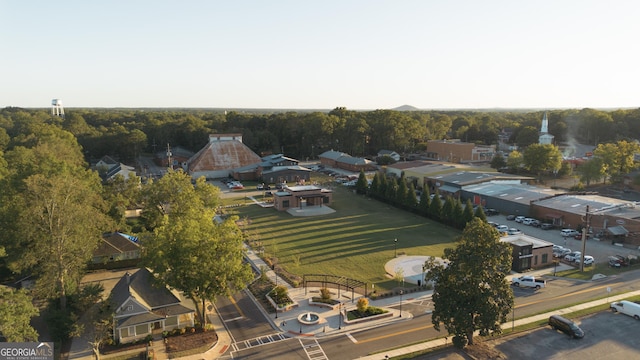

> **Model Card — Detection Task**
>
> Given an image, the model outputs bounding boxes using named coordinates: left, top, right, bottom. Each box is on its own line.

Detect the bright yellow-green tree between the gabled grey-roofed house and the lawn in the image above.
left=143, top=171, right=251, bottom=320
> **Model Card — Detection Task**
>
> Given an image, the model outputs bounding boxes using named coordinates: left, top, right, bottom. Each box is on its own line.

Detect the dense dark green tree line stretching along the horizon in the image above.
left=0, top=107, right=640, bottom=163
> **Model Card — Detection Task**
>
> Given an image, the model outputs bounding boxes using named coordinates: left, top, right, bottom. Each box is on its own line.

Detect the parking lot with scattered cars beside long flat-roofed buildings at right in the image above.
left=487, top=215, right=640, bottom=271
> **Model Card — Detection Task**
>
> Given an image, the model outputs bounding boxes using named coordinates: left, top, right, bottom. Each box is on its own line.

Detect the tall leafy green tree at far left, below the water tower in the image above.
left=0, top=124, right=110, bottom=309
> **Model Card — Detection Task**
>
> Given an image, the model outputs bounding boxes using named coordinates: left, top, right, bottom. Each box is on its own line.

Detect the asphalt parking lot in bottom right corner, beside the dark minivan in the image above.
left=491, top=311, right=640, bottom=360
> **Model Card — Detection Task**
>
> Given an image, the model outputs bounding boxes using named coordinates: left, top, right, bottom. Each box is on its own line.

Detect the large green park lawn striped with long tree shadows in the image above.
left=227, top=186, right=460, bottom=290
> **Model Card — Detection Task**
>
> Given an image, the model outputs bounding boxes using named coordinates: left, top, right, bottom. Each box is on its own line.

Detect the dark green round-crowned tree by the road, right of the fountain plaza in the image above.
left=426, top=218, right=513, bottom=347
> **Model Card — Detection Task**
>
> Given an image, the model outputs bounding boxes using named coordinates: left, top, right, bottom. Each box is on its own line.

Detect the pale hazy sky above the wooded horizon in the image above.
left=0, top=0, right=640, bottom=110
